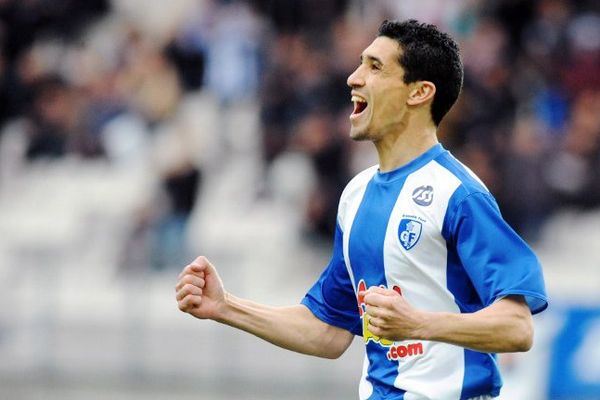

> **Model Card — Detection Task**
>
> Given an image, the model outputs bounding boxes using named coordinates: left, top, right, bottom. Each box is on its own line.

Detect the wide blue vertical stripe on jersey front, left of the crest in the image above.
left=348, top=176, right=406, bottom=400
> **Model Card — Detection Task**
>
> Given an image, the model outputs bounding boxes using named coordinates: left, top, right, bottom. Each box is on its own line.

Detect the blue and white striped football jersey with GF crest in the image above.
left=302, top=144, right=547, bottom=400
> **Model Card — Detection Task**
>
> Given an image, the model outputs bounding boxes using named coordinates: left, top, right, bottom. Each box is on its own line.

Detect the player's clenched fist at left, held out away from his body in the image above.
left=175, top=256, right=225, bottom=320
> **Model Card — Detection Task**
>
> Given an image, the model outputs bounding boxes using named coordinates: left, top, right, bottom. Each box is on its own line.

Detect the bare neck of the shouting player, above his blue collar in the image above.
left=374, top=124, right=438, bottom=172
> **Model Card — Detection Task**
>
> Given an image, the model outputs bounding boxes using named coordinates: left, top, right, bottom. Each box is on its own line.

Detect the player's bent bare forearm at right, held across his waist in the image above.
left=422, top=298, right=533, bottom=353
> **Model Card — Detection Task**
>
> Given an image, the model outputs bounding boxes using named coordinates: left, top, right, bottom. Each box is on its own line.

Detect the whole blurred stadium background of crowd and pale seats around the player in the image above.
left=0, top=0, right=600, bottom=400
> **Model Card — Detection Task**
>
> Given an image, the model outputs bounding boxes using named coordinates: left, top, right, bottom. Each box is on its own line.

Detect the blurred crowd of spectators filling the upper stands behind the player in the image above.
left=0, top=0, right=600, bottom=268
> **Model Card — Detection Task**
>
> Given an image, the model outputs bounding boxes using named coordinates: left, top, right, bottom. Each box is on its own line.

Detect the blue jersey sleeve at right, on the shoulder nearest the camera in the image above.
left=449, top=192, right=548, bottom=314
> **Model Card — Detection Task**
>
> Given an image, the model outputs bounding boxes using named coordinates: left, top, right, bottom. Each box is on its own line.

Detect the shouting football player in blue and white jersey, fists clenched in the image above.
left=176, top=20, right=547, bottom=400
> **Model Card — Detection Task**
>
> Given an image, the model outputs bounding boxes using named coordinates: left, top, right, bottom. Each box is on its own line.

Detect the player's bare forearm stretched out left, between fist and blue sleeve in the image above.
left=216, top=294, right=353, bottom=358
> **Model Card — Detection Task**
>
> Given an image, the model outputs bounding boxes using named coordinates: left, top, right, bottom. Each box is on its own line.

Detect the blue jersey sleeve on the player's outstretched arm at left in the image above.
left=302, top=225, right=362, bottom=335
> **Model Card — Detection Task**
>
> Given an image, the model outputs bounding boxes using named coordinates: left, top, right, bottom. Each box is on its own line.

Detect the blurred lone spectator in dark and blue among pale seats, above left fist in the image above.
left=121, top=124, right=203, bottom=272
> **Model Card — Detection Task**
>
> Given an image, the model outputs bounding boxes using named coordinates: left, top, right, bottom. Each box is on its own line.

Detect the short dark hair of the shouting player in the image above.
left=377, top=19, right=463, bottom=126
